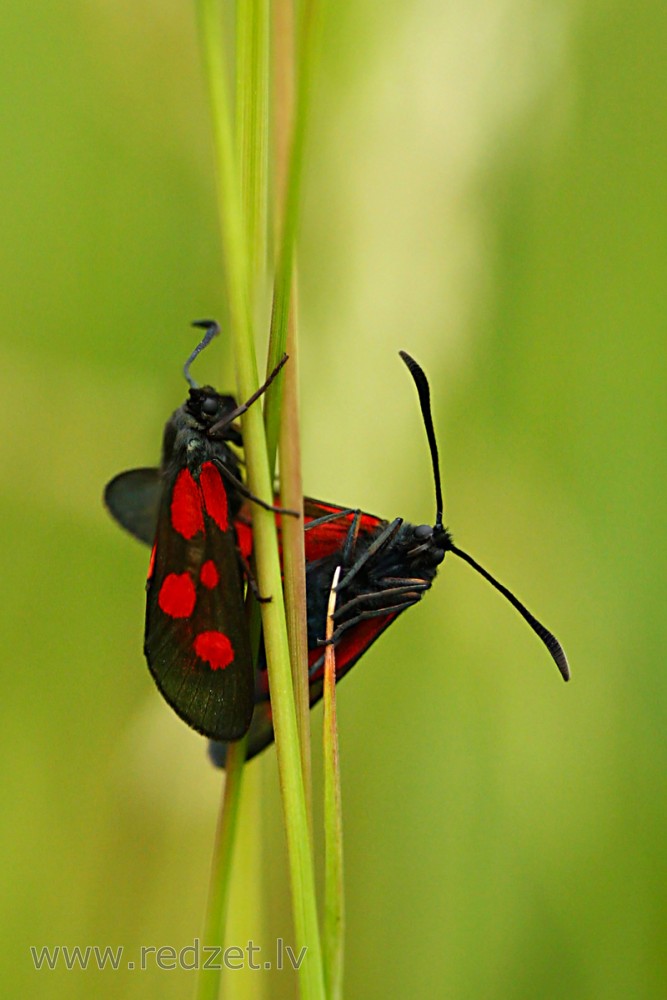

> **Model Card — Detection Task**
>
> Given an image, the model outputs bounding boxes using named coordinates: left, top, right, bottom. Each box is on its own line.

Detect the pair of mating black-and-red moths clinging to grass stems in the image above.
left=104, top=320, right=570, bottom=763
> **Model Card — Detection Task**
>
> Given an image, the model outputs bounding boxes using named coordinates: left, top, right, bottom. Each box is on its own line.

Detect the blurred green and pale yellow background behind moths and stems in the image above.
left=0, top=0, right=667, bottom=1000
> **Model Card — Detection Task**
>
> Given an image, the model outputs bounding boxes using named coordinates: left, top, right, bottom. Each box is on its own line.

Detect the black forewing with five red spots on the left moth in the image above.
left=145, top=462, right=254, bottom=740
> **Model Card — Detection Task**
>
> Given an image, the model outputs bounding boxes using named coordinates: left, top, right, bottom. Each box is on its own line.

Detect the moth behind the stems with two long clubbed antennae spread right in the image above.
left=210, top=351, right=570, bottom=766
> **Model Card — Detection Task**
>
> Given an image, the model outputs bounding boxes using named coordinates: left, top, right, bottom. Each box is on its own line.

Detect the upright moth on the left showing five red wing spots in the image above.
left=104, top=320, right=286, bottom=740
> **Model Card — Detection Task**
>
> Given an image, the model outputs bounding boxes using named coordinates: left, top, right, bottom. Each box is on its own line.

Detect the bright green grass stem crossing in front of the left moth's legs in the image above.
left=198, top=0, right=324, bottom=1000
